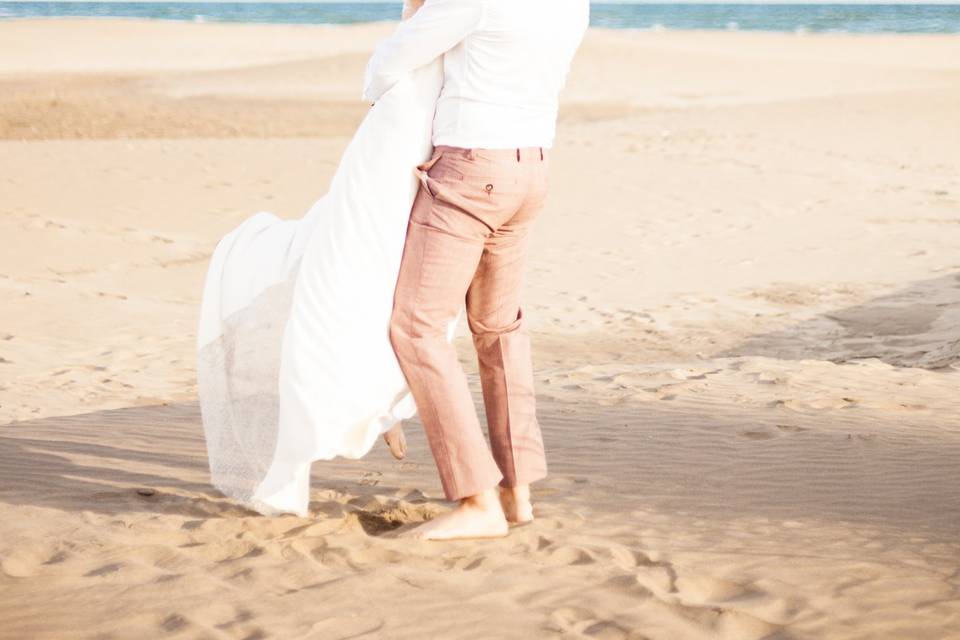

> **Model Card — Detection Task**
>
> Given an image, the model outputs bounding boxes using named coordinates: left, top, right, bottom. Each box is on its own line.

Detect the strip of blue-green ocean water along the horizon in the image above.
left=0, top=0, right=960, bottom=33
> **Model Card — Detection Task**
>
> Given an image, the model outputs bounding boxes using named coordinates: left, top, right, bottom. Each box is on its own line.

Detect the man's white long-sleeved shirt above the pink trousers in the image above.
left=363, top=0, right=590, bottom=149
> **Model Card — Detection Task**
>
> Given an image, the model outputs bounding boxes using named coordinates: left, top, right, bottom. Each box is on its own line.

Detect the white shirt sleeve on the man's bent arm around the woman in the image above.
left=363, top=0, right=483, bottom=102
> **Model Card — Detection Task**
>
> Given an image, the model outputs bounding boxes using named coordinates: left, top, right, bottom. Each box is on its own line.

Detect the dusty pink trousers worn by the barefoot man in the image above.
left=390, top=146, right=549, bottom=500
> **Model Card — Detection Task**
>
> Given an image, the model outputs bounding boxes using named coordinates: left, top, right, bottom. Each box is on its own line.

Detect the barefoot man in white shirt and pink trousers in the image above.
left=364, top=0, right=589, bottom=540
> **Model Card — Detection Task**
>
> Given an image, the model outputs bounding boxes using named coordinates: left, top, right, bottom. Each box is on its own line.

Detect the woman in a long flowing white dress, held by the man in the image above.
left=197, top=0, right=448, bottom=516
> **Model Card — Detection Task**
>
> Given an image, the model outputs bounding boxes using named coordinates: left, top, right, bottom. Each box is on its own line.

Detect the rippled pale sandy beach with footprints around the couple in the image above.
left=0, top=19, right=960, bottom=640
